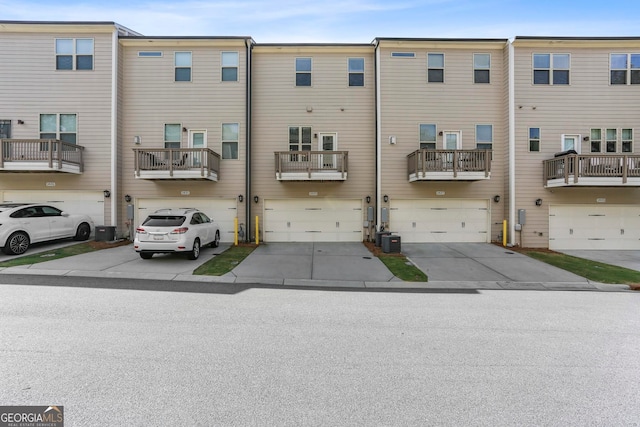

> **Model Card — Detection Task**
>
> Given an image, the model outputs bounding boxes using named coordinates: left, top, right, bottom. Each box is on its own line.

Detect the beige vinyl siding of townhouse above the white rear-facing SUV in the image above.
left=121, top=40, right=247, bottom=232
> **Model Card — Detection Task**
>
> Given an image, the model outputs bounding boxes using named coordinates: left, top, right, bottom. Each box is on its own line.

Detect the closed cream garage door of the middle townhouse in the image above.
left=264, top=199, right=363, bottom=242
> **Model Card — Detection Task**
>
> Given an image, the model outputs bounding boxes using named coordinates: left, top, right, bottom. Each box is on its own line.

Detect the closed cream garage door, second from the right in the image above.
left=389, top=199, right=490, bottom=243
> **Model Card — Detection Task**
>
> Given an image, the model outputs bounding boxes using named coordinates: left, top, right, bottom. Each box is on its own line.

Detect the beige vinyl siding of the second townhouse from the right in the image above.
left=380, top=42, right=508, bottom=244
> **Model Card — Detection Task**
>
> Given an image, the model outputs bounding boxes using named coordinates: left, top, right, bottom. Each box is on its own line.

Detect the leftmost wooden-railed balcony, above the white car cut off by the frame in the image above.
left=0, top=139, right=84, bottom=174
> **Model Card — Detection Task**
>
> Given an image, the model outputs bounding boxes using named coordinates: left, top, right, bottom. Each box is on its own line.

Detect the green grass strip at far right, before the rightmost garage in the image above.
left=522, top=250, right=640, bottom=284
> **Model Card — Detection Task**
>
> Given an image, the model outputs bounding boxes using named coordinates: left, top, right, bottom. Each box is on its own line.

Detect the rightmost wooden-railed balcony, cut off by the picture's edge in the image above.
left=543, top=154, right=640, bottom=188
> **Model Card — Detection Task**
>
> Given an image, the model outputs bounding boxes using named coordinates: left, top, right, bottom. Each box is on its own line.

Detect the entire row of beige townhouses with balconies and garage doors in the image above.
left=0, top=21, right=640, bottom=249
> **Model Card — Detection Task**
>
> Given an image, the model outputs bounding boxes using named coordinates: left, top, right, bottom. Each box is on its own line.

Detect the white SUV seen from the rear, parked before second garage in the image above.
left=133, top=208, right=220, bottom=259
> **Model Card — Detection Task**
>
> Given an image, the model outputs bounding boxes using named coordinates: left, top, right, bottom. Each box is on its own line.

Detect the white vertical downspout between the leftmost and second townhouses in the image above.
left=110, top=27, right=120, bottom=226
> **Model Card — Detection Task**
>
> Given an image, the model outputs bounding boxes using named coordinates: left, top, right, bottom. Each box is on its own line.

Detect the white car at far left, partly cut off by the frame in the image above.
left=0, top=203, right=94, bottom=255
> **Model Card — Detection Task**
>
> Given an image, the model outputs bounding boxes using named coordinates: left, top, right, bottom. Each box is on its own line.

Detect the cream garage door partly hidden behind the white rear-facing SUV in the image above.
left=139, top=197, right=238, bottom=242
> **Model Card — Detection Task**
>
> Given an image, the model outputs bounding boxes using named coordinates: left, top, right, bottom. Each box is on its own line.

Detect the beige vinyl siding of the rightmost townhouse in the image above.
left=514, top=41, right=640, bottom=247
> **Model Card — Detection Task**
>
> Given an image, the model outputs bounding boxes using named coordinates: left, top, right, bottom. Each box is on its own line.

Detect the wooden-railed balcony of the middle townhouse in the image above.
left=275, top=151, right=349, bottom=181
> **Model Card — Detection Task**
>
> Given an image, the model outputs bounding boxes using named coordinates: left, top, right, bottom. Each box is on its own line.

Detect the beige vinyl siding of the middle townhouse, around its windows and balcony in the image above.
left=252, top=45, right=376, bottom=242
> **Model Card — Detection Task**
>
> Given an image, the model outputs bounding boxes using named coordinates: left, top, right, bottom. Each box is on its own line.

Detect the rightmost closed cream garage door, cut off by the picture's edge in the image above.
left=549, top=205, right=640, bottom=250
